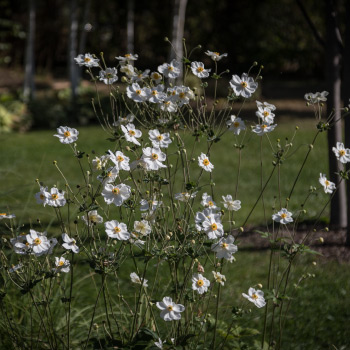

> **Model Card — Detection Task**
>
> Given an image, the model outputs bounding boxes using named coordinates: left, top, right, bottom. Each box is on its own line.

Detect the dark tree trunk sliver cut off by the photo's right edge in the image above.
left=342, top=0, right=350, bottom=242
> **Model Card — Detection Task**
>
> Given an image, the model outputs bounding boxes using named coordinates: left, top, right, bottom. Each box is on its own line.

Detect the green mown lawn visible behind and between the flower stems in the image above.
left=0, top=120, right=350, bottom=350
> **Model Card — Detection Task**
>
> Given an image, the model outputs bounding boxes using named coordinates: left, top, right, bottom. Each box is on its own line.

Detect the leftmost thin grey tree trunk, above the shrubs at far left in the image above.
left=23, top=0, right=36, bottom=102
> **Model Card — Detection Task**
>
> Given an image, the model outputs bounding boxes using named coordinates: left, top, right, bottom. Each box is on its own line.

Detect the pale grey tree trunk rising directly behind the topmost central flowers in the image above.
left=169, top=0, right=187, bottom=79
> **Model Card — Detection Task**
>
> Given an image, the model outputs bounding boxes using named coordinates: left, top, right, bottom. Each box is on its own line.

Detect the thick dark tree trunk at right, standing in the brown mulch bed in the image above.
left=326, top=0, right=347, bottom=228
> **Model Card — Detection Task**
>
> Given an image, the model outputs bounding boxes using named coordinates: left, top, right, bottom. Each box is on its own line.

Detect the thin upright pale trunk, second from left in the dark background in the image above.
left=68, top=0, right=78, bottom=104
